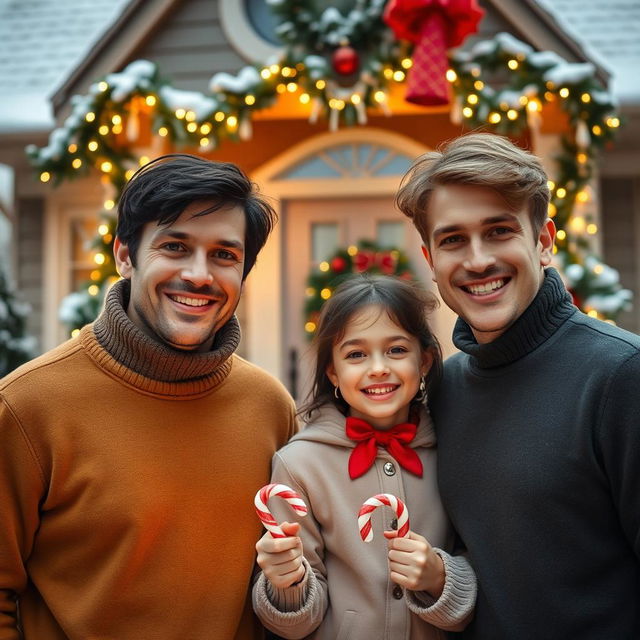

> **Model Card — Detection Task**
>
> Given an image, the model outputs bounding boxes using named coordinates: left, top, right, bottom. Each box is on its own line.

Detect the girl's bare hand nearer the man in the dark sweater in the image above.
left=384, top=531, right=445, bottom=600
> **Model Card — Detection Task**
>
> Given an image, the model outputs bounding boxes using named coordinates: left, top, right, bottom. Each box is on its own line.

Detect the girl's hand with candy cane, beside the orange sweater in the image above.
left=255, top=484, right=307, bottom=589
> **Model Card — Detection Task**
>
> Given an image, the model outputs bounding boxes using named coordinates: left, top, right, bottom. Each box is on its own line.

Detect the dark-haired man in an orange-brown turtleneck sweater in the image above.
left=0, top=154, right=296, bottom=640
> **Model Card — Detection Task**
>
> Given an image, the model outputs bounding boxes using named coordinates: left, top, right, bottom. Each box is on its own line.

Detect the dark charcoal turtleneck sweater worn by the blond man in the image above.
left=431, top=268, right=640, bottom=640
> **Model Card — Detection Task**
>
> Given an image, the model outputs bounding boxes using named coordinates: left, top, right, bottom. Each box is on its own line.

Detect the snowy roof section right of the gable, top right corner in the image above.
left=536, top=0, right=640, bottom=103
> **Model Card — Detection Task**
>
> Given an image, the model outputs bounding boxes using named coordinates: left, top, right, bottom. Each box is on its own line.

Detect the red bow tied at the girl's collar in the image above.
left=346, top=416, right=422, bottom=480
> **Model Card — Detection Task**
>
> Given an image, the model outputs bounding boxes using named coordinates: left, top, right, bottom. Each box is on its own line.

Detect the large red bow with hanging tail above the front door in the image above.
left=383, top=0, right=484, bottom=105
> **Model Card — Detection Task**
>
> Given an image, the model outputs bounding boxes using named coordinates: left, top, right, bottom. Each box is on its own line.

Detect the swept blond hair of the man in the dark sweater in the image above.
left=396, top=133, right=550, bottom=245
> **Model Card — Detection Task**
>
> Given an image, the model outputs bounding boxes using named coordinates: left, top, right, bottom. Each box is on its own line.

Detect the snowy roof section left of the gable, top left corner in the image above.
left=0, top=0, right=130, bottom=132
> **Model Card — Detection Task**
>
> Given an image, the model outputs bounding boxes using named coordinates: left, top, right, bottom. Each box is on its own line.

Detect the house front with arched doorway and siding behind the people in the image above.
left=0, top=0, right=640, bottom=397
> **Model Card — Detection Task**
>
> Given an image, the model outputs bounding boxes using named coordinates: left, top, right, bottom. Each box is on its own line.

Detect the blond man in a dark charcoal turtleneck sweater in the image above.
left=397, top=133, right=640, bottom=640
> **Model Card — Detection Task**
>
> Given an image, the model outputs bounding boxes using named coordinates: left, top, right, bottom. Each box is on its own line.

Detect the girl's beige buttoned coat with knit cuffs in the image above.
left=253, top=406, right=476, bottom=640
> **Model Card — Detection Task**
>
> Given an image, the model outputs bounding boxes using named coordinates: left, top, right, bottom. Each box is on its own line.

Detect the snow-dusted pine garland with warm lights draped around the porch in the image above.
left=27, top=11, right=631, bottom=328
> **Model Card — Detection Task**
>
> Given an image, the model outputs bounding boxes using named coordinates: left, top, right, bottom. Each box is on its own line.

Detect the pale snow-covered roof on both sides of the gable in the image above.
left=0, top=0, right=640, bottom=133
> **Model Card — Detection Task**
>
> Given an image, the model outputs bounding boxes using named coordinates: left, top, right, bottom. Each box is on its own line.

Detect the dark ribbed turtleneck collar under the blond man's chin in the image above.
left=453, top=268, right=576, bottom=369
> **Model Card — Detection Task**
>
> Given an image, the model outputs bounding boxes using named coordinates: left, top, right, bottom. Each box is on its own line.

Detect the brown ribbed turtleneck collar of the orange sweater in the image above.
left=80, top=280, right=240, bottom=395
